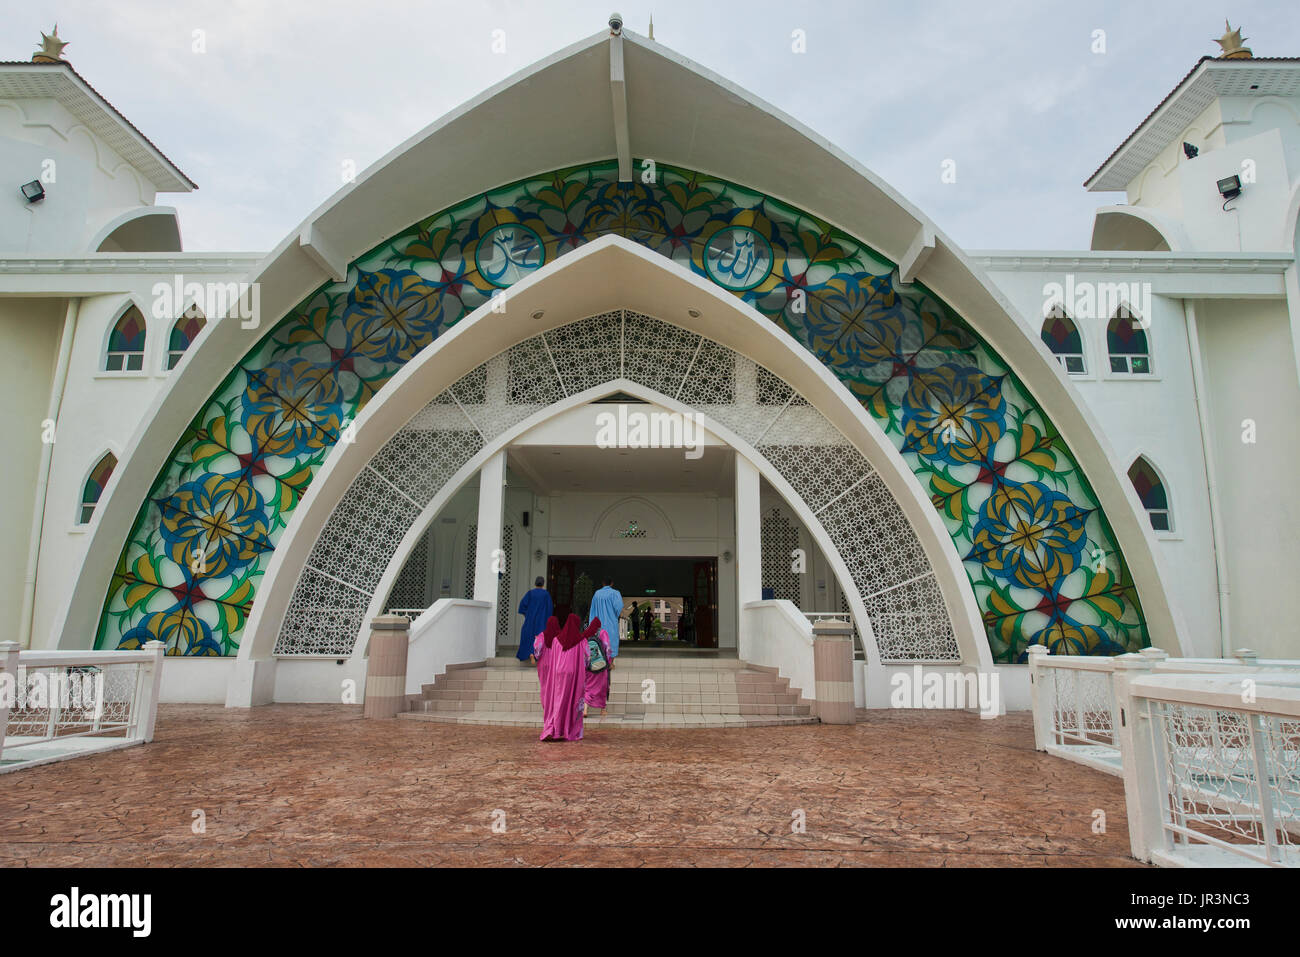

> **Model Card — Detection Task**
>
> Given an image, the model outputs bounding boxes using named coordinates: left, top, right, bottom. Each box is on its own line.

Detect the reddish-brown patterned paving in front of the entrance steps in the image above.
left=0, top=705, right=1135, bottom=866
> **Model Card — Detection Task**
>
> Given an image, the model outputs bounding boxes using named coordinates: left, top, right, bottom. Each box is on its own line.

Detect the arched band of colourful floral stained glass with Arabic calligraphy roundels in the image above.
left=98, top=160, right=1148, bottom=662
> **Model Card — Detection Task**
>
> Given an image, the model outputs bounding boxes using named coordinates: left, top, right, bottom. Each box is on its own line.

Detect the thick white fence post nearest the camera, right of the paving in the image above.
left=1110, top=651, right=1169, bottom=861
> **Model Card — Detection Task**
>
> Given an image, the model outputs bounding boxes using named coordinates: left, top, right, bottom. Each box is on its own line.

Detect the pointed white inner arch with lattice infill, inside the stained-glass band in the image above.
left=223, top=237, right=989, bottom=702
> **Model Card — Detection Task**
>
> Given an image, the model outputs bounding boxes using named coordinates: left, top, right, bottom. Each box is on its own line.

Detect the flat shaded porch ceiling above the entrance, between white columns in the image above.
left=507, top=446, right=736, bottom=495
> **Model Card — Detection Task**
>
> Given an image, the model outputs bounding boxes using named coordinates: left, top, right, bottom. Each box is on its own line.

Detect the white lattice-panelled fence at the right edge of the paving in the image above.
left=1030, top=649, right=1300, bottom=867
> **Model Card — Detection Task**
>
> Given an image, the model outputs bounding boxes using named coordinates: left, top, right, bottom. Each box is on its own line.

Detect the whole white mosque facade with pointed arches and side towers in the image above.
left=0, top=24, right=1300, bottom=707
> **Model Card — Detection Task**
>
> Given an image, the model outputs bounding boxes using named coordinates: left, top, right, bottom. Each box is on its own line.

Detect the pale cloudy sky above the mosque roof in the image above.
left=10, top=0, right=1300, bottom=251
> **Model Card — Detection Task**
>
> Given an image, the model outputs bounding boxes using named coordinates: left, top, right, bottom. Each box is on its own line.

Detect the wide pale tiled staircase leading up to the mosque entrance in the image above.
left=398, top=645, right=818, bottom=728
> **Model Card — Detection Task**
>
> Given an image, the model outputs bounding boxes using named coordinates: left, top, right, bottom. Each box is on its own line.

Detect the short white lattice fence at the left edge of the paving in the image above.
left=0, top=641, right=164, bottom=772
